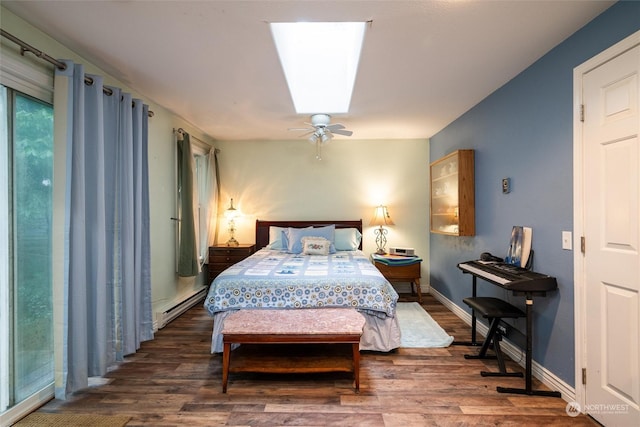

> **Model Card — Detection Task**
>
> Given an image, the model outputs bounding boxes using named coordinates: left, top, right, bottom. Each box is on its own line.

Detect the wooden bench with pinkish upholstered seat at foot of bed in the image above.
left=222, top=308, right=365, bottom=393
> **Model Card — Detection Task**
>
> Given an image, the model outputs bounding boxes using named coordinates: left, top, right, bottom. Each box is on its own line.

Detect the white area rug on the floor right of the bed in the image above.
left=396, top=302, right=453, bottom=348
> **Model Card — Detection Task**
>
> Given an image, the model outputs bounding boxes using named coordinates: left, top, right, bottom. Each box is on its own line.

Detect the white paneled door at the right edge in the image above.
left=582, top=38, right=640, bottom=427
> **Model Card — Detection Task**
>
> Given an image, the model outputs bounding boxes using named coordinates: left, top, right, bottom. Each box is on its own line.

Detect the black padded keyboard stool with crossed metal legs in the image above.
left=462, top=297, right=526, bottom=377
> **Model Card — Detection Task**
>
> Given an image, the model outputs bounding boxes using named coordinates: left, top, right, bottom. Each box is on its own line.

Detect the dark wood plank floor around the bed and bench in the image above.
left=31, top=295, right=598, bottom=427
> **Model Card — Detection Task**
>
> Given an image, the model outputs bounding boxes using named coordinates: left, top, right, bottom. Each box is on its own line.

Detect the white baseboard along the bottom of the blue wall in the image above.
left=429, top=288, right=576, bottom=402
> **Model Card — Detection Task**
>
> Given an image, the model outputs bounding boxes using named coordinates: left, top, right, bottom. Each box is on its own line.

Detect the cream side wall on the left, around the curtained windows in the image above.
left=0, top=8, right=215, bottom=318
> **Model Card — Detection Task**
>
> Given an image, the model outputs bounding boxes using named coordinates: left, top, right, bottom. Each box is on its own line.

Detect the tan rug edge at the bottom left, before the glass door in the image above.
left=14, top=412, right=131, bottom=427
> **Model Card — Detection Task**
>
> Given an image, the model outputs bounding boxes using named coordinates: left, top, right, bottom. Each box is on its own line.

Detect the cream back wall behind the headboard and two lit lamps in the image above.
left=216, top=137, right=429, bottom=284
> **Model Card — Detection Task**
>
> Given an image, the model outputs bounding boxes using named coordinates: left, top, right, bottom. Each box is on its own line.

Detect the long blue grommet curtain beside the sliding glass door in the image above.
left=54, top=61, right=153, bottom=399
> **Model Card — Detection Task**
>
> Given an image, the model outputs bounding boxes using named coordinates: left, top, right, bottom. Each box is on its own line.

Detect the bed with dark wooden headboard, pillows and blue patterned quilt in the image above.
left=204, top=220, right=400, bottom=353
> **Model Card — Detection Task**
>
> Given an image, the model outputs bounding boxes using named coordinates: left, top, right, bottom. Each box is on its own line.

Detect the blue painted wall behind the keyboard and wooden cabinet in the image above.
left=429, top=1, right=640, bottom=386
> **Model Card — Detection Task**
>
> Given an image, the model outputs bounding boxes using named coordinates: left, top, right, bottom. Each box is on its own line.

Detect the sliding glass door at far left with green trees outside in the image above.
left=0, top=86, right=54, bottom=413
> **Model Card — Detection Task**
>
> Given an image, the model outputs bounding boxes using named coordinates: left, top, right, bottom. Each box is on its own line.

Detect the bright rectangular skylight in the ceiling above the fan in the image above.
left=270, top=22, right=366, bottom=114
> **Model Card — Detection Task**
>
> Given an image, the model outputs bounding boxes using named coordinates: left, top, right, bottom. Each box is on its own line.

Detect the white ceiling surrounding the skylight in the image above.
left=2, top=0, right=614, bottom=140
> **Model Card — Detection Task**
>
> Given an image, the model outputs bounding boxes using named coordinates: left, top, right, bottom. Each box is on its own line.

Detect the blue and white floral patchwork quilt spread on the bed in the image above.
left=204, top=249, right=398, bottom=317
